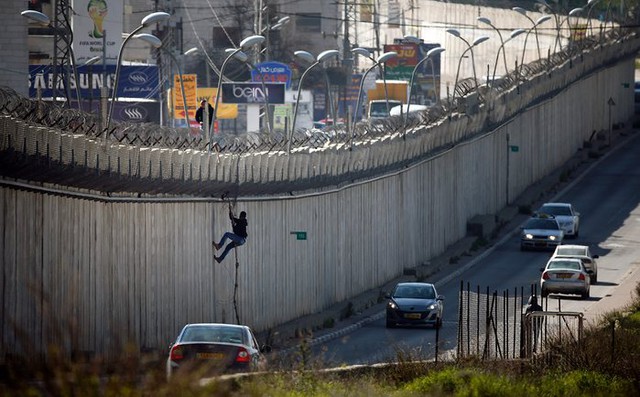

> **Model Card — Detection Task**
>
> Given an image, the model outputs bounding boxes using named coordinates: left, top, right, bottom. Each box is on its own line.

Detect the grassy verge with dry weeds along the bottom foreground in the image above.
left=0, top=285, right=640, bottom=397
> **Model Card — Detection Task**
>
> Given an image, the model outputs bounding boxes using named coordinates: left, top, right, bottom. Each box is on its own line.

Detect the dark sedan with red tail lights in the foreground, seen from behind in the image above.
left=167, top=323, right=271, bottom=379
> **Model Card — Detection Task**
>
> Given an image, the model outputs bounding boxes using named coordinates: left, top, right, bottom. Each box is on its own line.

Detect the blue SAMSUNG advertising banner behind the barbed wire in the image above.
left=29, top=65, right=160, bottom=99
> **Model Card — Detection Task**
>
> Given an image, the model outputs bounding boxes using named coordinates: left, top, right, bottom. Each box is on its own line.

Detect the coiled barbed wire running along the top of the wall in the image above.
left=0, top=24, right=625, bottom=154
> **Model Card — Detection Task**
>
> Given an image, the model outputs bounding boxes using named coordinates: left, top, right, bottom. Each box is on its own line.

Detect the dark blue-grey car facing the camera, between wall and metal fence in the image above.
left=387, top=282, right=444, bottom=328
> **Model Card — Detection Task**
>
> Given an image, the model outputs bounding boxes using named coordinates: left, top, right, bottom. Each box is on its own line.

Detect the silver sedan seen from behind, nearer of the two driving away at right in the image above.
left=540, top=257, right=591, bottom=299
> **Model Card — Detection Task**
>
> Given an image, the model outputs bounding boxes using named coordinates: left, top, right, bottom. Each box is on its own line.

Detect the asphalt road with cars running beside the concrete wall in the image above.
left=296, top=135, right=640, bottom=367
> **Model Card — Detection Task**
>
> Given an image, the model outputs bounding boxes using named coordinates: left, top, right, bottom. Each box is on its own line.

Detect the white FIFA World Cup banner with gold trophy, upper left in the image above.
left=71, top=0, right=124, bottom=65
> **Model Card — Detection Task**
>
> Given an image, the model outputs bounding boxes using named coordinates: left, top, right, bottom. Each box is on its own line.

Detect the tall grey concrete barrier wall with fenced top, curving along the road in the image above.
left=0, top=30, right=639, bottom=358
